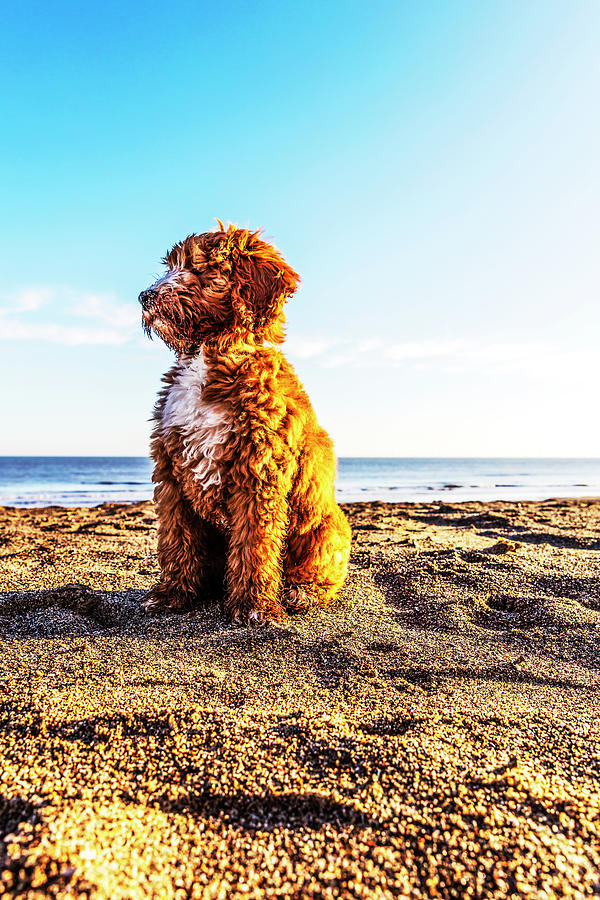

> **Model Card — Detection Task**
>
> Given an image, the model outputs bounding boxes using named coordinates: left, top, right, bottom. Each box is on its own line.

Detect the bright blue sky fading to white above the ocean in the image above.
left=0, top=0, right=600, bottom=456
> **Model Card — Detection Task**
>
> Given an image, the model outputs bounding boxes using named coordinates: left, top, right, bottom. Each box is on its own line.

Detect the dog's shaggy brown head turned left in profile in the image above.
left=139, top=222, right=299, bottom=354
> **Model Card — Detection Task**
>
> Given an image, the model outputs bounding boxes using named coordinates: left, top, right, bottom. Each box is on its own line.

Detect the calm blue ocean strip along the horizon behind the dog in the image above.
left=0, top=456, right=600, bottom=507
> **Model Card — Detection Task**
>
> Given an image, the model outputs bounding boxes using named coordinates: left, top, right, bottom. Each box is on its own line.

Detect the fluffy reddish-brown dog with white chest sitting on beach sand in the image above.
left=139, top=220, right=350, bottom=624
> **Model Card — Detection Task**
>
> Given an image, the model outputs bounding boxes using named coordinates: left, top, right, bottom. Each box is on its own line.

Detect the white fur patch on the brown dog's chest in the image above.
left=160, top=350, right=233, bottom=489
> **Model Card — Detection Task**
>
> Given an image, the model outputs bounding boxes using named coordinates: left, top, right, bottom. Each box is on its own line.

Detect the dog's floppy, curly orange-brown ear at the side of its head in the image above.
left=224, top=231, right=300, bottom=341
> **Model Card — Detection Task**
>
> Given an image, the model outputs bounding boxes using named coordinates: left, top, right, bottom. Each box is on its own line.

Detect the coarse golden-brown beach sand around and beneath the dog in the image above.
left=0, top=499, right=600, bottom=898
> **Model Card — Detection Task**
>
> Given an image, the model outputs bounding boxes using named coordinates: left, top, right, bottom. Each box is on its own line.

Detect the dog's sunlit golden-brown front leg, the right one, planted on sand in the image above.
left=225, top=471, right=288, bottom=625
